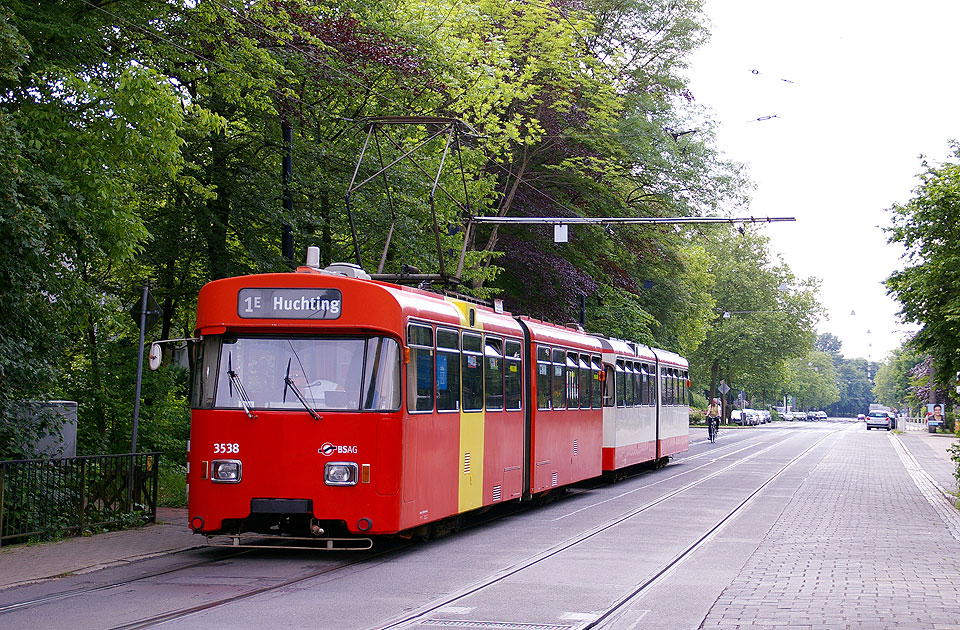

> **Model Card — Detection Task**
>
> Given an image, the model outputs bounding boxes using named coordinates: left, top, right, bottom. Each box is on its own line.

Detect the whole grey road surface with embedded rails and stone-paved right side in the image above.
left=0, top=422, right=960, bottom=630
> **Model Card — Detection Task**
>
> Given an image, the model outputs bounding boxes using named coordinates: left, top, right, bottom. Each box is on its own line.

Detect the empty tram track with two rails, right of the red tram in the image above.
left=371, top=429, right=842, bottom=630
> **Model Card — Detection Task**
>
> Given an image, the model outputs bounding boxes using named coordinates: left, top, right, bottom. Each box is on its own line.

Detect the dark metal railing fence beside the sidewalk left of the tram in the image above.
left=0, top=453, right=160, bottom=545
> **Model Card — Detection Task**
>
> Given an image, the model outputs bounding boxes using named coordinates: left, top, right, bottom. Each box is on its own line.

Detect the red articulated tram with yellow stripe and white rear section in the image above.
left=187, top=256, right=688, bottom=548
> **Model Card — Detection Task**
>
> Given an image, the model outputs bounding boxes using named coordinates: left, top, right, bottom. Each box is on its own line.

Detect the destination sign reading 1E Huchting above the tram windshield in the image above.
left=237, top=289, right=343, bottom=319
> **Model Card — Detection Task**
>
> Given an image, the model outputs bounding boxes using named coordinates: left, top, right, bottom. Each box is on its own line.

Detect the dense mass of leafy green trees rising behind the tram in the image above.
left=0, top=0, right=817, bottom=470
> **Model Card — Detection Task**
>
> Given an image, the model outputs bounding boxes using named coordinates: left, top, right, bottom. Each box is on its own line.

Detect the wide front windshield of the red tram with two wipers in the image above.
left=194, top=335, right=401, bottom=411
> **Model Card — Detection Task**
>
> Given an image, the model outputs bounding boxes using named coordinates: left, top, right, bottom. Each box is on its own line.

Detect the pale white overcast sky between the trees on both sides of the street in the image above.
left=688, top=0, right=960, bottom=361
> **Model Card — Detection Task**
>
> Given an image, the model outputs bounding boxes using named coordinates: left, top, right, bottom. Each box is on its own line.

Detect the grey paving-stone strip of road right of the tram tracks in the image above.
left=701, top=431, right=960, bottom=630
